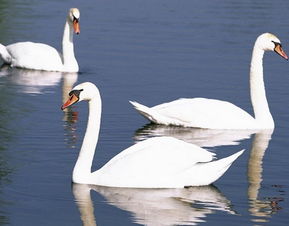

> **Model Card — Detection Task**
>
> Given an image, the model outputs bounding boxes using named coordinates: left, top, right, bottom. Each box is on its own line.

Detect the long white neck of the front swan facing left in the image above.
left=72, top=93, right=101, bottom=183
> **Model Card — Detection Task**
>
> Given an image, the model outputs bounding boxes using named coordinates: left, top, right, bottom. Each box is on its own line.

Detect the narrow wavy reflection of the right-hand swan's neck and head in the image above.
left=247, top=130, right=283, bottom=222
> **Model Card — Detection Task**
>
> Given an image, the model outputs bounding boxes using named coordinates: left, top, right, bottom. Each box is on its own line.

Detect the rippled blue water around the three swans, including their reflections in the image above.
left=0, top=0, right=289, bottom=225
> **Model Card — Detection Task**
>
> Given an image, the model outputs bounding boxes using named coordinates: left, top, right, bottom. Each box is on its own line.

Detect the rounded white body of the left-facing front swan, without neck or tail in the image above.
left=91, top=137, right=215, bottom=188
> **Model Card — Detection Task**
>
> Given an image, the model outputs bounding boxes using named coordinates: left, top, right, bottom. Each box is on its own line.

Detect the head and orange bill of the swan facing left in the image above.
left=61, top=82, right=100, bottom=110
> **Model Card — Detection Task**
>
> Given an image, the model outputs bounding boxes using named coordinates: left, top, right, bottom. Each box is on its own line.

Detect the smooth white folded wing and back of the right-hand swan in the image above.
left=152, top=98, right=255, bottom=128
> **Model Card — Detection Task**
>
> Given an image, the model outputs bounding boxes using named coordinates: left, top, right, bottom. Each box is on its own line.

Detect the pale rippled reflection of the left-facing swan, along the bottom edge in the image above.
left=72, top=184, right=235, bottom=226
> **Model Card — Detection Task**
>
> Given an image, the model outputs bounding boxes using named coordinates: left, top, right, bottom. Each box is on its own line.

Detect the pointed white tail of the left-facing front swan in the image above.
left=185, top=150, right=245, bottom=187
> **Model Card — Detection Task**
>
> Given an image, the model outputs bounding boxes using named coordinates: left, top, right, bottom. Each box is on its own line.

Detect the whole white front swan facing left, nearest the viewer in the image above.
left=61, top=82, right=243, bottom=188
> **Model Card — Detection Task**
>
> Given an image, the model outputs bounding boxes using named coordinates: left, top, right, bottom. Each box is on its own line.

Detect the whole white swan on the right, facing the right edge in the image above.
left=130, top=33, right=288, bottom=129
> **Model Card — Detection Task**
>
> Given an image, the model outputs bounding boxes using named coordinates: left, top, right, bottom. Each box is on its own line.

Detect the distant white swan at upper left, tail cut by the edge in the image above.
left=0, top=8, right=80, bottom=72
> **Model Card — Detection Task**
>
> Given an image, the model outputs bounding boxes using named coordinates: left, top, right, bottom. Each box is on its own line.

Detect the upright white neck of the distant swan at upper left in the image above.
left=62, top=21, right=78, bottom=72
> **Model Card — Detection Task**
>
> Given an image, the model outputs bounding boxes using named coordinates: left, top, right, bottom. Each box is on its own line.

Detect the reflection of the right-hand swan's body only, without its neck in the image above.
left=134, top=124, right=256, bottom=147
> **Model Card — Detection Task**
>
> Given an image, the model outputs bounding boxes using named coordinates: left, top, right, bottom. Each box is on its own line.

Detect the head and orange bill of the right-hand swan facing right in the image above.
left=255, top=33, right=288, bottom=60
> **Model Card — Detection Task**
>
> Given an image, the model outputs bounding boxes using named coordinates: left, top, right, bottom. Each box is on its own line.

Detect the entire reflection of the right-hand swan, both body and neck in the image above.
left=134, top=124, right=283, bottom=222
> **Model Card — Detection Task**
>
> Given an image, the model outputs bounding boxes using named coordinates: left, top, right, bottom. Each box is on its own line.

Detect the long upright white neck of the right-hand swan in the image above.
left=250, top=44, right=274, bottom=128
